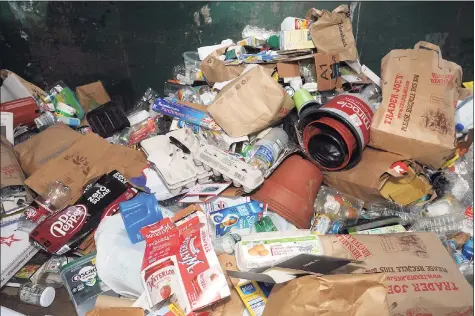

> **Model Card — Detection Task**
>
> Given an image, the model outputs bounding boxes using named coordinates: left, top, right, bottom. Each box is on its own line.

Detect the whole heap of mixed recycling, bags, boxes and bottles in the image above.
left=1, top=5, right=474, bottom=316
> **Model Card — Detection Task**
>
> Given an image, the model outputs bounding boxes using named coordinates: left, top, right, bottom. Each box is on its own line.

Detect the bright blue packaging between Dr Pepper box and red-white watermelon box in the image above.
left=119, top=192, right=163, bottom=244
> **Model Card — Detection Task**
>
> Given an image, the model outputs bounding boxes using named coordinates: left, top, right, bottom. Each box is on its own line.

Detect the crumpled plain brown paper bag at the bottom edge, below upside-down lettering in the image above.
left=262, top=273, right=389, bottom=316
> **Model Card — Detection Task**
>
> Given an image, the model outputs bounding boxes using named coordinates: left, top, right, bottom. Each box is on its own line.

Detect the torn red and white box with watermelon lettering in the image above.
left=141, top=211, right=231, bottom=315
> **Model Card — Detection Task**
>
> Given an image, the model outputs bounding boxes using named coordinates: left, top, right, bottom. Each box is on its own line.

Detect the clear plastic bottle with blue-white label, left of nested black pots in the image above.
left=249, top=127, right=289, bottom=173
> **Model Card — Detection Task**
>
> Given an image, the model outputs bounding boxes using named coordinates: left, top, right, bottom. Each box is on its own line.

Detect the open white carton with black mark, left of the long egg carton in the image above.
left=140, top=129, right=213, bottom=194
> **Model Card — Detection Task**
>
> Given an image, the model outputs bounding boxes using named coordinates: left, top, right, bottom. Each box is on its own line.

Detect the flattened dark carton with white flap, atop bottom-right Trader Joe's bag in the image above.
left=227, top=253, right=353, bottom=284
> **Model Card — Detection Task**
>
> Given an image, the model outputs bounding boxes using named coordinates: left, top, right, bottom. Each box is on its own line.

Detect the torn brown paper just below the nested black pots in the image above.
left=323, top=147, right=407, bottom=204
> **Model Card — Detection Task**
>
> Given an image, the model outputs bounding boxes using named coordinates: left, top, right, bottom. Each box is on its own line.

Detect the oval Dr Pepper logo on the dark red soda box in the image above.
left=49, top=205, right=87, bottom=238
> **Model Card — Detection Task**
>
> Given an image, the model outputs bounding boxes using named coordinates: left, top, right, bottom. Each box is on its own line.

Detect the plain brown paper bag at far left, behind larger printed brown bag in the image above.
left=14, top=123, right=83, bottom=176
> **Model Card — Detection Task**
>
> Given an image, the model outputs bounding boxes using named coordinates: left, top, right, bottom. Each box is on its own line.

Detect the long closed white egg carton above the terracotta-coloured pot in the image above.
left=193, top=144, right=264, bottom=193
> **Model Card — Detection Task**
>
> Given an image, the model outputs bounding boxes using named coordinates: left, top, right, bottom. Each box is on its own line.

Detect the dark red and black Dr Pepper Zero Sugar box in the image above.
left=30, top=170, right=137, bottom=254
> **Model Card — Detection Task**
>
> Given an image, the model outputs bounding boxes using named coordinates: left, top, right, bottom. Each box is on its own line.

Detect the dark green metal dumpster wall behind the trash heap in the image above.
left=0, top=2, right=474, bottom=108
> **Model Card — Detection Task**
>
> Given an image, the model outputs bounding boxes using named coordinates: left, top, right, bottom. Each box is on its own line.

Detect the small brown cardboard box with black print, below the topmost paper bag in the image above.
left=314, top=53, right=342, bottom=91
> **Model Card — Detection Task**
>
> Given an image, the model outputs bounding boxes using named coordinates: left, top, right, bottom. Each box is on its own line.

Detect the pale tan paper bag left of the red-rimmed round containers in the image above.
left=208, top=65, right=295, bottom=137
